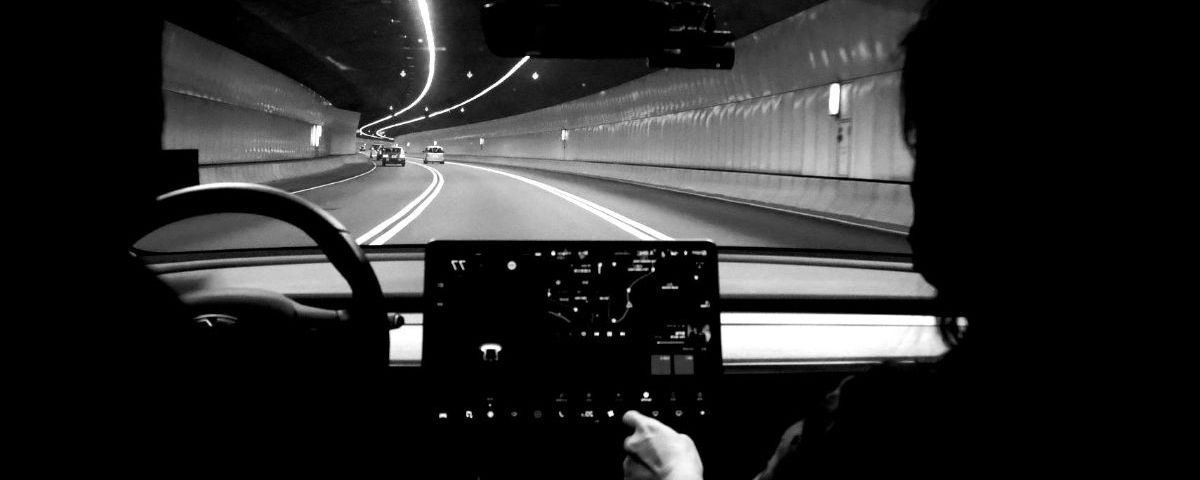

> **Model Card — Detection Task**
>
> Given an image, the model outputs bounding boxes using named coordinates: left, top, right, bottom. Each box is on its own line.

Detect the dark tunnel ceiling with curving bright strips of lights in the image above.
left=163, top=0, right=823, bottom=136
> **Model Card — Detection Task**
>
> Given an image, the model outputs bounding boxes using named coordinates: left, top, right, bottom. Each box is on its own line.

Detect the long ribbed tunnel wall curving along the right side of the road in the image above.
left=396, top=0, right=923, bottom=230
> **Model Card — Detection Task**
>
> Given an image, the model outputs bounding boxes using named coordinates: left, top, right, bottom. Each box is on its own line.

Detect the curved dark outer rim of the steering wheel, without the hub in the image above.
left=126, top=182, right=389, bottom=366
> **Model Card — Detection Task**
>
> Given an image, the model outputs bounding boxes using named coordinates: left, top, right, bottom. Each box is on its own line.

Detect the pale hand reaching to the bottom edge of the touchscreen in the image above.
left=622, top=410, right=704, bottom=480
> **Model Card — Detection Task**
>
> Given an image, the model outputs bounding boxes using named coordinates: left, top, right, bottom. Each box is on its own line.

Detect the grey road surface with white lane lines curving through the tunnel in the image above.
left=138, top=158, right=910, bottom=253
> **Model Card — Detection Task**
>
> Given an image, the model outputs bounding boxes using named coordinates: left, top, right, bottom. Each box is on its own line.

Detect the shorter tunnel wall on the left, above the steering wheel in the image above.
left=162, top=23, right=365, bottom=182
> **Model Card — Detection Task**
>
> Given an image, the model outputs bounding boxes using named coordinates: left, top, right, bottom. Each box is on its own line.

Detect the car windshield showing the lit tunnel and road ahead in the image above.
left=147, top=0, right=920, bottom=254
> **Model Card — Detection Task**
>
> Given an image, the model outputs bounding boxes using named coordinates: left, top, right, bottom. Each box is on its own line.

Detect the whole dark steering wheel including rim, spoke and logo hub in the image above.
left=130, top=182, right=390, bottom=372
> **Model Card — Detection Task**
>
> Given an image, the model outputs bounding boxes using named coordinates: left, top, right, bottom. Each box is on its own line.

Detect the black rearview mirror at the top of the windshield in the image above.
left=481, top=0, right=734, bottom=70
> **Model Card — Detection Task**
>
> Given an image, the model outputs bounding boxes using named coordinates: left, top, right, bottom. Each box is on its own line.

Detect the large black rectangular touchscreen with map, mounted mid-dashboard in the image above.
left=421, top=241, right=721, bottom=425
